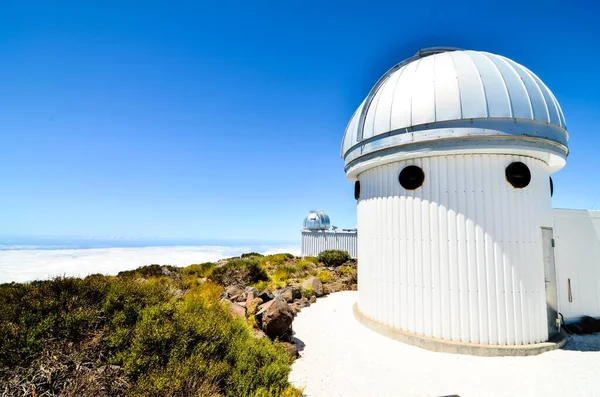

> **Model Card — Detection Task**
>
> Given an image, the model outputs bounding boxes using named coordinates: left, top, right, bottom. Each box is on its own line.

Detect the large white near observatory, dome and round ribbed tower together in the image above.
left=341, top=48, right=568, bottom=348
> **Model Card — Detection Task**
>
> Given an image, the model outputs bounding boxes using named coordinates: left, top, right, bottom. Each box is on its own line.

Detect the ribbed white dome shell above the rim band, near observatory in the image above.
left=342, top=50, right=566, bottom=157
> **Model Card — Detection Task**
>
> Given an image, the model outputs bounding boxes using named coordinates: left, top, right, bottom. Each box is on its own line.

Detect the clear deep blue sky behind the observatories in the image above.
left=0, top=0, right=600, bottom=240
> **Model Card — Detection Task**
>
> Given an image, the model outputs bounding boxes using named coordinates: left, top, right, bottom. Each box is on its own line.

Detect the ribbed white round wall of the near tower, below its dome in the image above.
left=358, top=155, right=552, bottom=345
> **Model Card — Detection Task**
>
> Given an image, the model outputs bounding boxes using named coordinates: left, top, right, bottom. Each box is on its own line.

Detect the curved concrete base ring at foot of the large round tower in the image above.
left=352, top=303, right=568, bottom=357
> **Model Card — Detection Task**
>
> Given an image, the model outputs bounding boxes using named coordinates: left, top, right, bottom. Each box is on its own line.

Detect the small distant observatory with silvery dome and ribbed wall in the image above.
left=301, top=210, right=356, bottom=258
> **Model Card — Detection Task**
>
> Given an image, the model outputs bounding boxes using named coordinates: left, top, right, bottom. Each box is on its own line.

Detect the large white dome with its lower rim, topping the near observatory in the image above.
left=341, top=48, right=568, bottom=180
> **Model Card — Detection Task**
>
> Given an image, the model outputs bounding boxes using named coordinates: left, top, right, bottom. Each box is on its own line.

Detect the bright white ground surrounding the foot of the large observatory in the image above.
left=290, top=291, right=600, bottom=397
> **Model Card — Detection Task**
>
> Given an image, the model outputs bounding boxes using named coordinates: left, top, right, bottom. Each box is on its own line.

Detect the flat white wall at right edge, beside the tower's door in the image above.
left=553, top=209, right=600, bottom=321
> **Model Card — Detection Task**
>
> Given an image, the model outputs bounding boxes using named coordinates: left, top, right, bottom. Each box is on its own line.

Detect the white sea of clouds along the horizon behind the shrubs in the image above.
left=0, top=245, right=300, bottom=283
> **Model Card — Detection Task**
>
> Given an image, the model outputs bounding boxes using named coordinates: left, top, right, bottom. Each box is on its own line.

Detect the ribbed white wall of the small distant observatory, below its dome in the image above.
left=302, top=230, right=357, bottom=258
